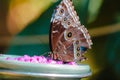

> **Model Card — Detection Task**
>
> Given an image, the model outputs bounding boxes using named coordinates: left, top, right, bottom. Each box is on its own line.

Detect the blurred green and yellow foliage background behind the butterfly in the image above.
left=0, top=0, right=120, bottom=80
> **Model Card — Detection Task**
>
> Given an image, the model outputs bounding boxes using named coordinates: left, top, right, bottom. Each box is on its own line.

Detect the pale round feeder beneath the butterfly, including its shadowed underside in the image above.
left=0, top=55, right=91, bottom=80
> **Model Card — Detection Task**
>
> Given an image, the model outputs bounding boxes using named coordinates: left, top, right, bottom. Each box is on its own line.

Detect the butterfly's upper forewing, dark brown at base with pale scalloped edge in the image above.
left=50, top=0, right=80, bottom=51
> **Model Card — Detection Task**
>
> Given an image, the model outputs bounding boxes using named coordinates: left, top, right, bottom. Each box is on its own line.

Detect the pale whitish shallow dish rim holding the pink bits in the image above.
left=0, top=55, right=91, bottom=78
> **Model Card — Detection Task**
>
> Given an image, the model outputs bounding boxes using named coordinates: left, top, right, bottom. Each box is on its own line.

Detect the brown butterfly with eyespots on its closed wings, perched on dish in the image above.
left=50, top=0, right=92, bottom=62
